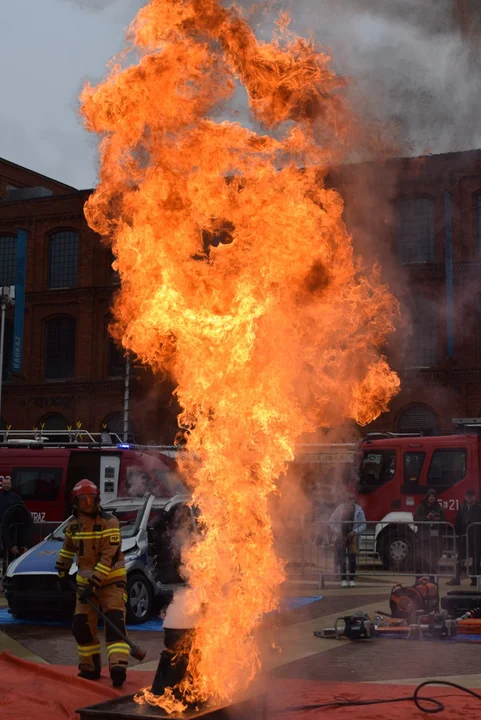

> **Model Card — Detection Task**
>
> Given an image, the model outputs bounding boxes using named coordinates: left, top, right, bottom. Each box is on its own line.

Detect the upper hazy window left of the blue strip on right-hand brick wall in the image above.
left=397, top=198, right=435, bottom=265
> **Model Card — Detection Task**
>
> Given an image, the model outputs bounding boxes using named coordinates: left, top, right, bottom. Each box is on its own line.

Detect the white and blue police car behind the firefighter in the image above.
left=4, top=495, right=196, bottom=624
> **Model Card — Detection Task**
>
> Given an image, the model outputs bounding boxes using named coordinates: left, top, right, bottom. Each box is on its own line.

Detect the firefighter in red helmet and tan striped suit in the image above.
left=56, top=480, right=130, bottom=687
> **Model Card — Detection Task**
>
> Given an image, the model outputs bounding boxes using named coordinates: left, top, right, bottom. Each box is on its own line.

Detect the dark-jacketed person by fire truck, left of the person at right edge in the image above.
left=414, top=490, right=446, bottom=579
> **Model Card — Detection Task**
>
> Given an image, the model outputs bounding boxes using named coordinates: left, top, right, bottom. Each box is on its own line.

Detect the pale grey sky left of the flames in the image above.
left=0, top=0, right=142, bottom=188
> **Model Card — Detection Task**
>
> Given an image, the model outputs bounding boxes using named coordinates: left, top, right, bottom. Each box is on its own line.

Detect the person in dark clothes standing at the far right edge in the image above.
left=448, top=490, right=481, bottom=587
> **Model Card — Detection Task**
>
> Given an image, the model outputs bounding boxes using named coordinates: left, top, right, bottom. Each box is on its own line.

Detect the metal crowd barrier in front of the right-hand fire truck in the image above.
left=285, top=520, right=458, bottom=587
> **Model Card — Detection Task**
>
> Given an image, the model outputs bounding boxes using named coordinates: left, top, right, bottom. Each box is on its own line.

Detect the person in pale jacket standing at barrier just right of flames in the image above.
left=329, top=493, right=366, bottom=587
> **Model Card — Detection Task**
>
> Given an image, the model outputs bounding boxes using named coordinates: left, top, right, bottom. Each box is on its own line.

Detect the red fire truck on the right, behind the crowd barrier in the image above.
left=358, top=418, right=481, bottom=565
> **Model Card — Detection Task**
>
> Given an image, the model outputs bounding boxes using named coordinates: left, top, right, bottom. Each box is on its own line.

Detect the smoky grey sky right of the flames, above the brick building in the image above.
left=283, top=0, right=481, bottom=155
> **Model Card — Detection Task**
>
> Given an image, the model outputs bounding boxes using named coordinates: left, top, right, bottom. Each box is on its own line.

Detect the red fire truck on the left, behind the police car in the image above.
left=0, top=430, right=183, bottom=522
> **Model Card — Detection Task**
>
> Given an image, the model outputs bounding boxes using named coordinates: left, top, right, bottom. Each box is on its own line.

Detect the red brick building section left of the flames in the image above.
left=0, top=159, right=175, bottom=443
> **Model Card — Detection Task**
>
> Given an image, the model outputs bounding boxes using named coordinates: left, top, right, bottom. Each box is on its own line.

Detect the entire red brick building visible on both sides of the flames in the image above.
left=0, top=151, right=481, bottom=442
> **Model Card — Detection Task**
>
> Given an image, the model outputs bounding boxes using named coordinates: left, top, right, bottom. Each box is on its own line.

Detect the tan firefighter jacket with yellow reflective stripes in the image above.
left=56, top=510, right=126, bottom=587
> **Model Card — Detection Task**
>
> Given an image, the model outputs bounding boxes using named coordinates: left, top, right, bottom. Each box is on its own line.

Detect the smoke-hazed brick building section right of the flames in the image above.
left=335, top=151, right=481, bottom=434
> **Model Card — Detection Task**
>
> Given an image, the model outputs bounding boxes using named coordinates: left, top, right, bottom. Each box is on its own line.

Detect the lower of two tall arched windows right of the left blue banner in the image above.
left=45, top=315, right=75, bottom=380
